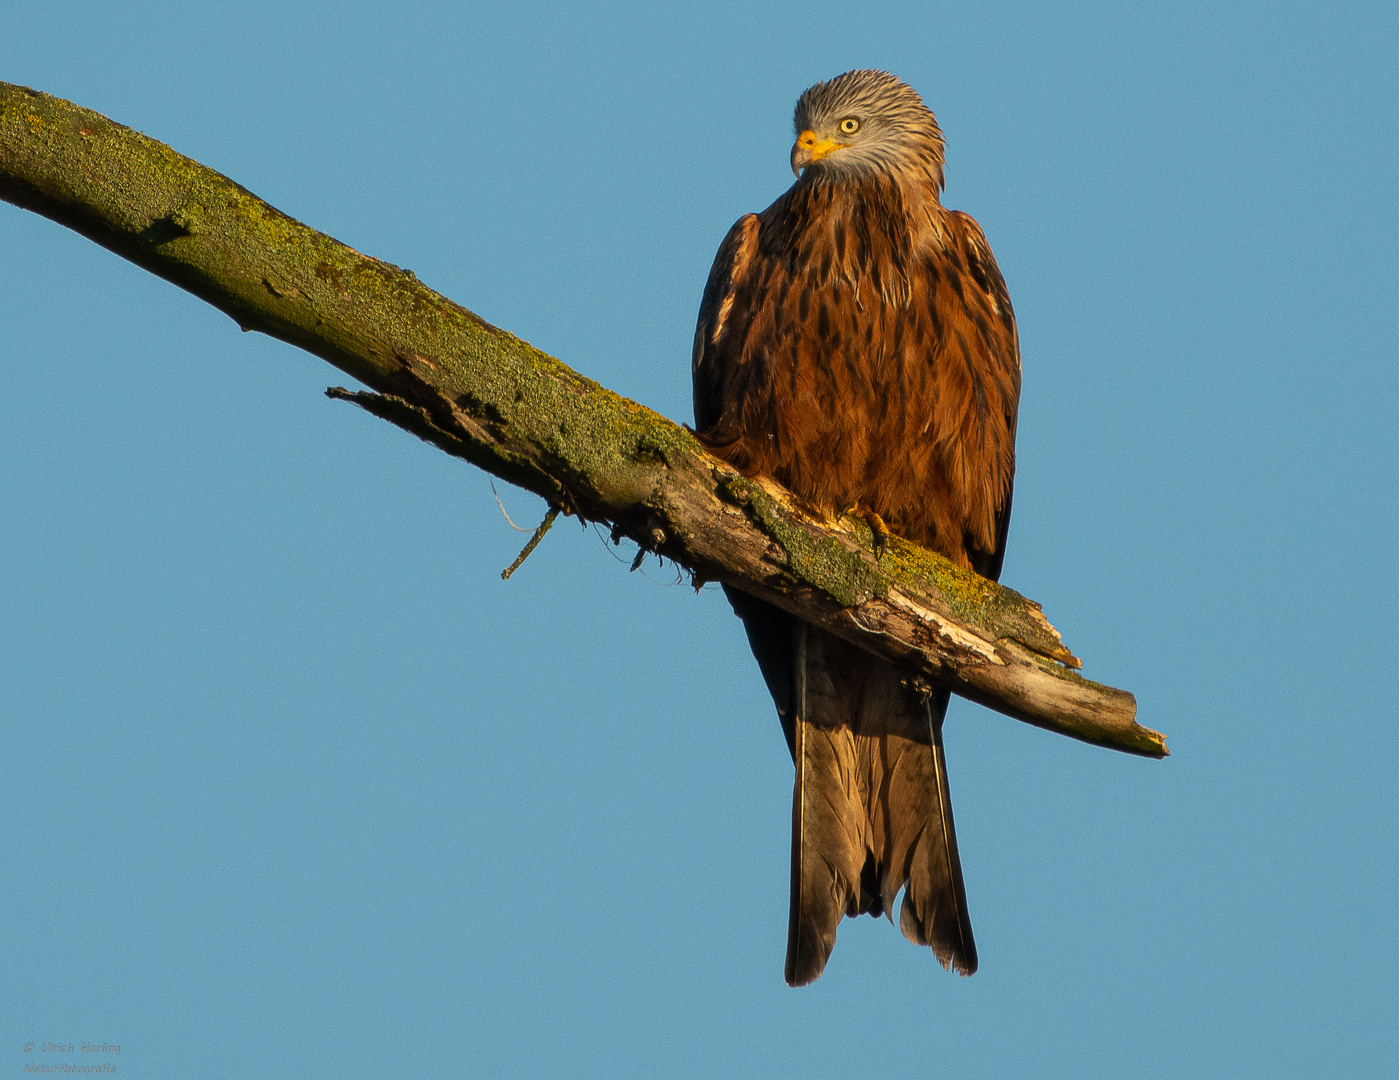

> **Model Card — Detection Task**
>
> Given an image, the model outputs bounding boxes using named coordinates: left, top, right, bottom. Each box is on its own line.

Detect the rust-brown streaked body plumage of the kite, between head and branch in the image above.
left=694, top=178, right=1020, bottom=581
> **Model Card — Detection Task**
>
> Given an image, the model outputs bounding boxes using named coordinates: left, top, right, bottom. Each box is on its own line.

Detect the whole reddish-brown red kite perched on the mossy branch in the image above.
left=693, top=71, right=1020, bottom=986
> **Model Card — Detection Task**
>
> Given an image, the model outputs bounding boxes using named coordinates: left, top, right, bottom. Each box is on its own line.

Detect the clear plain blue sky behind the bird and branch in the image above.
left=0, top=0, right=1399, bottom=1080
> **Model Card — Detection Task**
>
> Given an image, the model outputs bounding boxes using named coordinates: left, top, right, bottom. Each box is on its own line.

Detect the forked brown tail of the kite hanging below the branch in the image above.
left=786, top=623, right=977, bottom=986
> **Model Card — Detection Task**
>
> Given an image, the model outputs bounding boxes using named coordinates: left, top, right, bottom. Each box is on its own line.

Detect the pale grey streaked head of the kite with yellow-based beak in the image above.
left=792, top=71, right=943, bottom=190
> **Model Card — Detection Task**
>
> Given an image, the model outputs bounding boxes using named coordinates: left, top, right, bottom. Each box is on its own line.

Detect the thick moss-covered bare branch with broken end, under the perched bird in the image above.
left=0, top=83, right=1167, bottom=757
